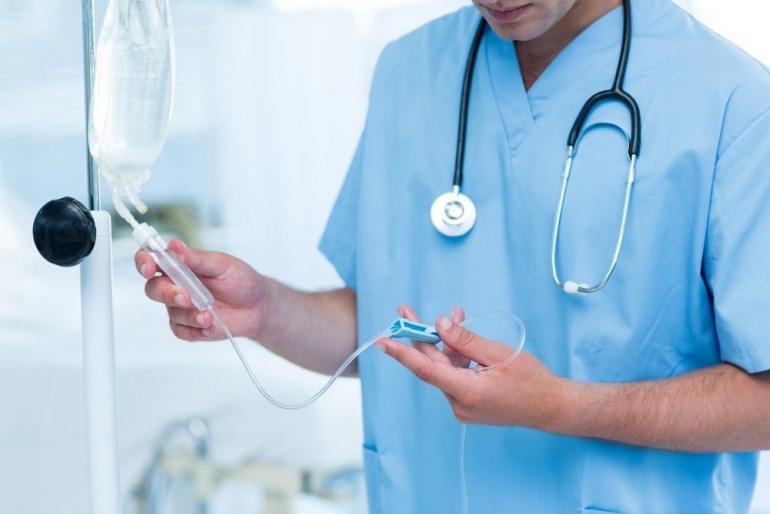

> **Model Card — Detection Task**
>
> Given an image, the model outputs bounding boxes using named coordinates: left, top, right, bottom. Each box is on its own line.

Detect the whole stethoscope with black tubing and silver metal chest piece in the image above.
left=430, top=0, right=641, bottom=293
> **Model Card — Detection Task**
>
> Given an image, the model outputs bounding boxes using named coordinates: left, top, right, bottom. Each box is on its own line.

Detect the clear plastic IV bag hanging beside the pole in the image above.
left=88, top=0, right=174, bottom=225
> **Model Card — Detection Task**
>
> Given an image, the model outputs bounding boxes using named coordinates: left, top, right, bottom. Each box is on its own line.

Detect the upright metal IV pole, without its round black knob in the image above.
left=80, top=0, right=122, bottom=514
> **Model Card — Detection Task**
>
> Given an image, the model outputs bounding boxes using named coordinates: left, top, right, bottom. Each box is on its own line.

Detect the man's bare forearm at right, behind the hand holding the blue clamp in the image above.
left=551, top=364, right=770, bottom=452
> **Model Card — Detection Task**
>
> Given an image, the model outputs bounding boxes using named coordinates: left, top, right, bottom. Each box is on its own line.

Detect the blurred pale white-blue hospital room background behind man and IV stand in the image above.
left=0, top=0, right=770, bottom=514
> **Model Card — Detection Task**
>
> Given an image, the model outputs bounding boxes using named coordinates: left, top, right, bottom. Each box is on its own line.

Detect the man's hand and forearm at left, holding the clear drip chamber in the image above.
left=135, top=240, right=356, bottom=374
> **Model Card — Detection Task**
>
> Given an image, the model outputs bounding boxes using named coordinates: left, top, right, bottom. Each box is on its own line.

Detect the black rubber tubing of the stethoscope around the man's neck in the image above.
left=453, top=0, right=641, bottom=188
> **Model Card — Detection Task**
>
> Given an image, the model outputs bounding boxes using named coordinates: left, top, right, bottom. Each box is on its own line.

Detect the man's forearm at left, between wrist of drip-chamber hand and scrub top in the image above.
left=252, top=279, right=357, bottom=375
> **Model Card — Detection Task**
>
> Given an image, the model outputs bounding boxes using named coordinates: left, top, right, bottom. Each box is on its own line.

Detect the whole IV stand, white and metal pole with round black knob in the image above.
left=32, top=0, right=121, bottom=514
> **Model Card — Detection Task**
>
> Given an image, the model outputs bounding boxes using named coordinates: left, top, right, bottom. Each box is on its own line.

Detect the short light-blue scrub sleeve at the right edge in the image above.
left=704, top=103, right=770, bottom=373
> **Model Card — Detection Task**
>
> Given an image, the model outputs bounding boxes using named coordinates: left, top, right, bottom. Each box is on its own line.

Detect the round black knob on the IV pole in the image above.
left=32, top=196, right=96, bottom=267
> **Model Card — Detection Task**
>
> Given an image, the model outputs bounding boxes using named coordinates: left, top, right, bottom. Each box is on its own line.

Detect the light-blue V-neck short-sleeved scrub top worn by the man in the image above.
left=320, top=0, right=770, bottom=514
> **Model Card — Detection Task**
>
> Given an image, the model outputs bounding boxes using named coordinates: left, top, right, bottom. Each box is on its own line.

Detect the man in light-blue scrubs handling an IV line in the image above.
left=137, top=0, right=770, bottom=514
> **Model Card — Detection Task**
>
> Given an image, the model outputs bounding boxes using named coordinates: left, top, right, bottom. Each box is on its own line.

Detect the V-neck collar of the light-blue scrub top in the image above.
left=483, top=0, right=640, bottom=152
